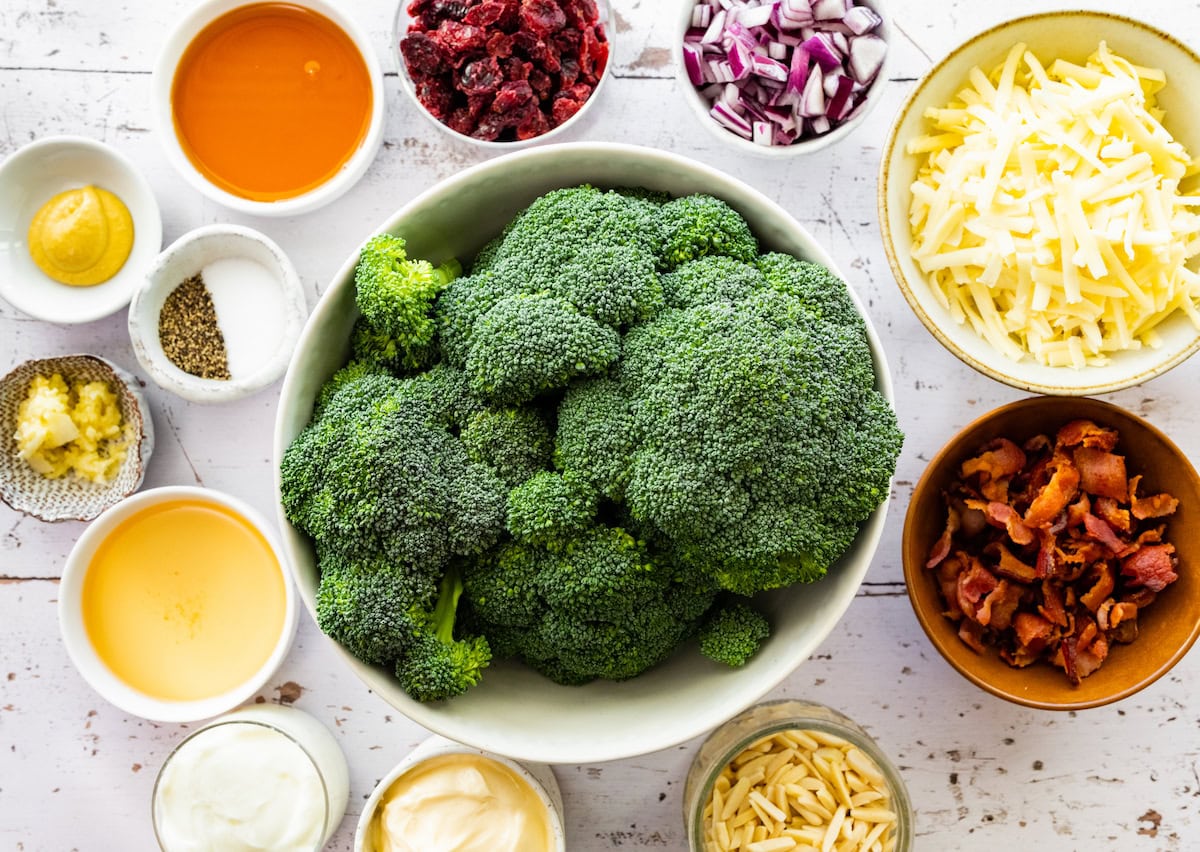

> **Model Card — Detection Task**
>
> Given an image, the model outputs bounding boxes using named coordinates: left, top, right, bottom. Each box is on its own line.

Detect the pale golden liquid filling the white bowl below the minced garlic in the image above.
left=82, top=499, right=287, bottom=701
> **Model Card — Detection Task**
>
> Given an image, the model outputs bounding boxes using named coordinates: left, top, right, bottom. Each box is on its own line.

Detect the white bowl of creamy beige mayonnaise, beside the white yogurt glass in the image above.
left=354, top=737, right=566, bottom=852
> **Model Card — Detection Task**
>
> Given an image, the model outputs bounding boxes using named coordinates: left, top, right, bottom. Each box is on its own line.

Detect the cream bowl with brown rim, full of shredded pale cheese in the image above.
left=878, top=11, right=1200, bottom=396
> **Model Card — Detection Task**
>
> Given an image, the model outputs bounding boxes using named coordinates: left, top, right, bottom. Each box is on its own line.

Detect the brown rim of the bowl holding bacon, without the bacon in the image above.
left=900, top=395, right=1200, bottom=710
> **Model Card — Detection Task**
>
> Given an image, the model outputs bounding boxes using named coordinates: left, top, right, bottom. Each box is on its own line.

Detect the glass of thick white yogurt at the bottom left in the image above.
left=152, top=704, right=349, bottom=852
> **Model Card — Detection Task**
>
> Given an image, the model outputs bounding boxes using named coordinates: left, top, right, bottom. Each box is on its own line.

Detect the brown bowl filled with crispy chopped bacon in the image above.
left=904, top=397, right=1200, bottom=710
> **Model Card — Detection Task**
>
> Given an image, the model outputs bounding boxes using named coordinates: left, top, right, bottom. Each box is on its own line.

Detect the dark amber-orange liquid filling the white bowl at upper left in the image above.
left=170, top=2, right=373, bottom=202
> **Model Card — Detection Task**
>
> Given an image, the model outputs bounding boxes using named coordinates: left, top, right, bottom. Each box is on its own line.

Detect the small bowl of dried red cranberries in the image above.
left=391, top=0, right=612, bottom=150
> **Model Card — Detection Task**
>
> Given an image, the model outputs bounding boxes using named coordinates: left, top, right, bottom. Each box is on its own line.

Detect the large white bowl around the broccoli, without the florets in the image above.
left=275, top=144, right=892, bottom=763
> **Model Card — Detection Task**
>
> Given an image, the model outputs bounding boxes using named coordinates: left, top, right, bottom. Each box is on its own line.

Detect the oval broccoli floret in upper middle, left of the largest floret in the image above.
left=467, top=294, right=620, bottom=404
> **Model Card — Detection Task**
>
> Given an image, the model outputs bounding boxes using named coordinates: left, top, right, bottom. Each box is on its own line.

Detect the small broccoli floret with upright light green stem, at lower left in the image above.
left=396, top=569, right=492, bottom=701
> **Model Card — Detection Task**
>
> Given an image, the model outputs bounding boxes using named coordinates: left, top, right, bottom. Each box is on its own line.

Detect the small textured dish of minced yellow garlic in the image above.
left=0, top=355, right=154, bottom=521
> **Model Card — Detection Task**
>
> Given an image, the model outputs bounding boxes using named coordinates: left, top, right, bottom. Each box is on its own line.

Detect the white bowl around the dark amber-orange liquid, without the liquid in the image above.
left=150, top=0, right=386, bottom=216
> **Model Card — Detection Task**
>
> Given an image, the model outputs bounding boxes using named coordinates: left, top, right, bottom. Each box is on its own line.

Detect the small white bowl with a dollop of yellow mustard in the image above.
left=0, top=136, right=162, bottom=324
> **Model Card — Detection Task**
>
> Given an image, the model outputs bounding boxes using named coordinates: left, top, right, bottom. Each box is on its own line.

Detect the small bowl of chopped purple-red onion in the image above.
left=676, top=0, right=892, bottom=156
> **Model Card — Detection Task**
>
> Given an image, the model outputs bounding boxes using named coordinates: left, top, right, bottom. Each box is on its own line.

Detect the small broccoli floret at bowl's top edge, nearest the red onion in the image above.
left=661, top=196, right=758, bottom=269
